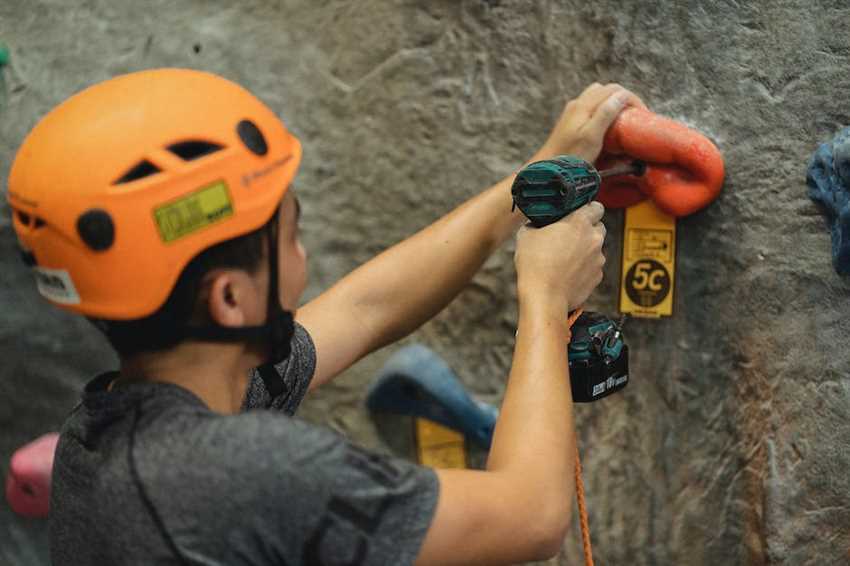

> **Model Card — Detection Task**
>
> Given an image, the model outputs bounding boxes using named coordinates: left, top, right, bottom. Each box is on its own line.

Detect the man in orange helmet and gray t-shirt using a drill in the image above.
left=8, top=69, right=642, bottom=566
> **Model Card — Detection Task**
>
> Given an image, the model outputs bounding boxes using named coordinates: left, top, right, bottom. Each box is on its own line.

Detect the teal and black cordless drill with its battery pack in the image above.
left=511, top=155, right=646, bottom=403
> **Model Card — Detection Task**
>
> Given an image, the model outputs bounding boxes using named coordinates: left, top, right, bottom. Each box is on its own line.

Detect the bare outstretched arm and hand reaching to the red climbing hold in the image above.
left=297, top=84, right=641, bottom=388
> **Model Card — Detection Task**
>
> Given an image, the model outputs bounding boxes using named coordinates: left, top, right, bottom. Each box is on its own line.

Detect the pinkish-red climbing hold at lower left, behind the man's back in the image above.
left=6, top=432, right=59, bottom=517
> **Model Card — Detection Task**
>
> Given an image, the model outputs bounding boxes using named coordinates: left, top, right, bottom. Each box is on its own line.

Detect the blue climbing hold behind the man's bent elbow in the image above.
left=366, top=344, right=499, bottom=448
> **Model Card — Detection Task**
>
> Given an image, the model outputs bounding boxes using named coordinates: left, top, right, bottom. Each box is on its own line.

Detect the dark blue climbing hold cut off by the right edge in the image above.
left=806, top=128, right=850, bottom=275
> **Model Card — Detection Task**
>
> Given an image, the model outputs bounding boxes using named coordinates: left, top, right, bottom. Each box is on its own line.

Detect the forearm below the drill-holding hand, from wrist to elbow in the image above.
left=487, top=299, right=575, bottom=520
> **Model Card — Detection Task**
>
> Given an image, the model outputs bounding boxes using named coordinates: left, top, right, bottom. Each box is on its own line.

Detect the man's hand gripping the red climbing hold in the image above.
left=534, top=83, right=646, bottom=163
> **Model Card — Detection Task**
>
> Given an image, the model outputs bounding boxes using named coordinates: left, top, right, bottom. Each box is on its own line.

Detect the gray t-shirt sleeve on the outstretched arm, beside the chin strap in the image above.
left=242, top=322, right=316, bottom=415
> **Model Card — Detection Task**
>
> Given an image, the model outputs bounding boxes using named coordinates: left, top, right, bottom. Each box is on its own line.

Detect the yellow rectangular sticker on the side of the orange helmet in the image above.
left=154, top=181, right=233, bottom=243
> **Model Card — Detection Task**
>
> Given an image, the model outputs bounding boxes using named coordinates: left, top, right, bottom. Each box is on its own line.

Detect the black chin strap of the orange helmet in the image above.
left=184, top=212, right=295, bottom=397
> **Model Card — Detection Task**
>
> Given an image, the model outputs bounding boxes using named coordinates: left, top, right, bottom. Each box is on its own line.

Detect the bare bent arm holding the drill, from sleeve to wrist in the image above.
left=417, top=300, right=575, bottom=565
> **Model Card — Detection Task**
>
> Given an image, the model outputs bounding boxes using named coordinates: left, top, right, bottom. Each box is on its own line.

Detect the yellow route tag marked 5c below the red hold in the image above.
left=620, top=200, right=676, bottom=318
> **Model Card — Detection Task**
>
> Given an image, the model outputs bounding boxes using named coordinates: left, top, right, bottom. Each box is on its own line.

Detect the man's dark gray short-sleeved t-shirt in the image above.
left=50, top=326, right=438, bottom=566
